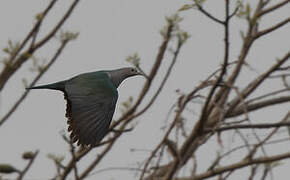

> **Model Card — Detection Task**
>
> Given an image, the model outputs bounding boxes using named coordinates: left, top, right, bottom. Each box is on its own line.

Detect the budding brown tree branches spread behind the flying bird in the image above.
left=0, top=0, right=290, bottom=180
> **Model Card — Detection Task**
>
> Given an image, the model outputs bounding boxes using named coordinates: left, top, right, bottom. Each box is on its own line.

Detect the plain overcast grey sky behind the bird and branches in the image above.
left=0, top=0, right=290, bottom=180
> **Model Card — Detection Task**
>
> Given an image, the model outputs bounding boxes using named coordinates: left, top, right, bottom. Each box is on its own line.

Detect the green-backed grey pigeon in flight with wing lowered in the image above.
left=27, top=67, right=143, bottom=146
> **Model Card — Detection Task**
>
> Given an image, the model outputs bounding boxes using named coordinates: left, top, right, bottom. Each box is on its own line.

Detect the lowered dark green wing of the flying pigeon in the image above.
left=64, top=74, right=118, bottom=146
